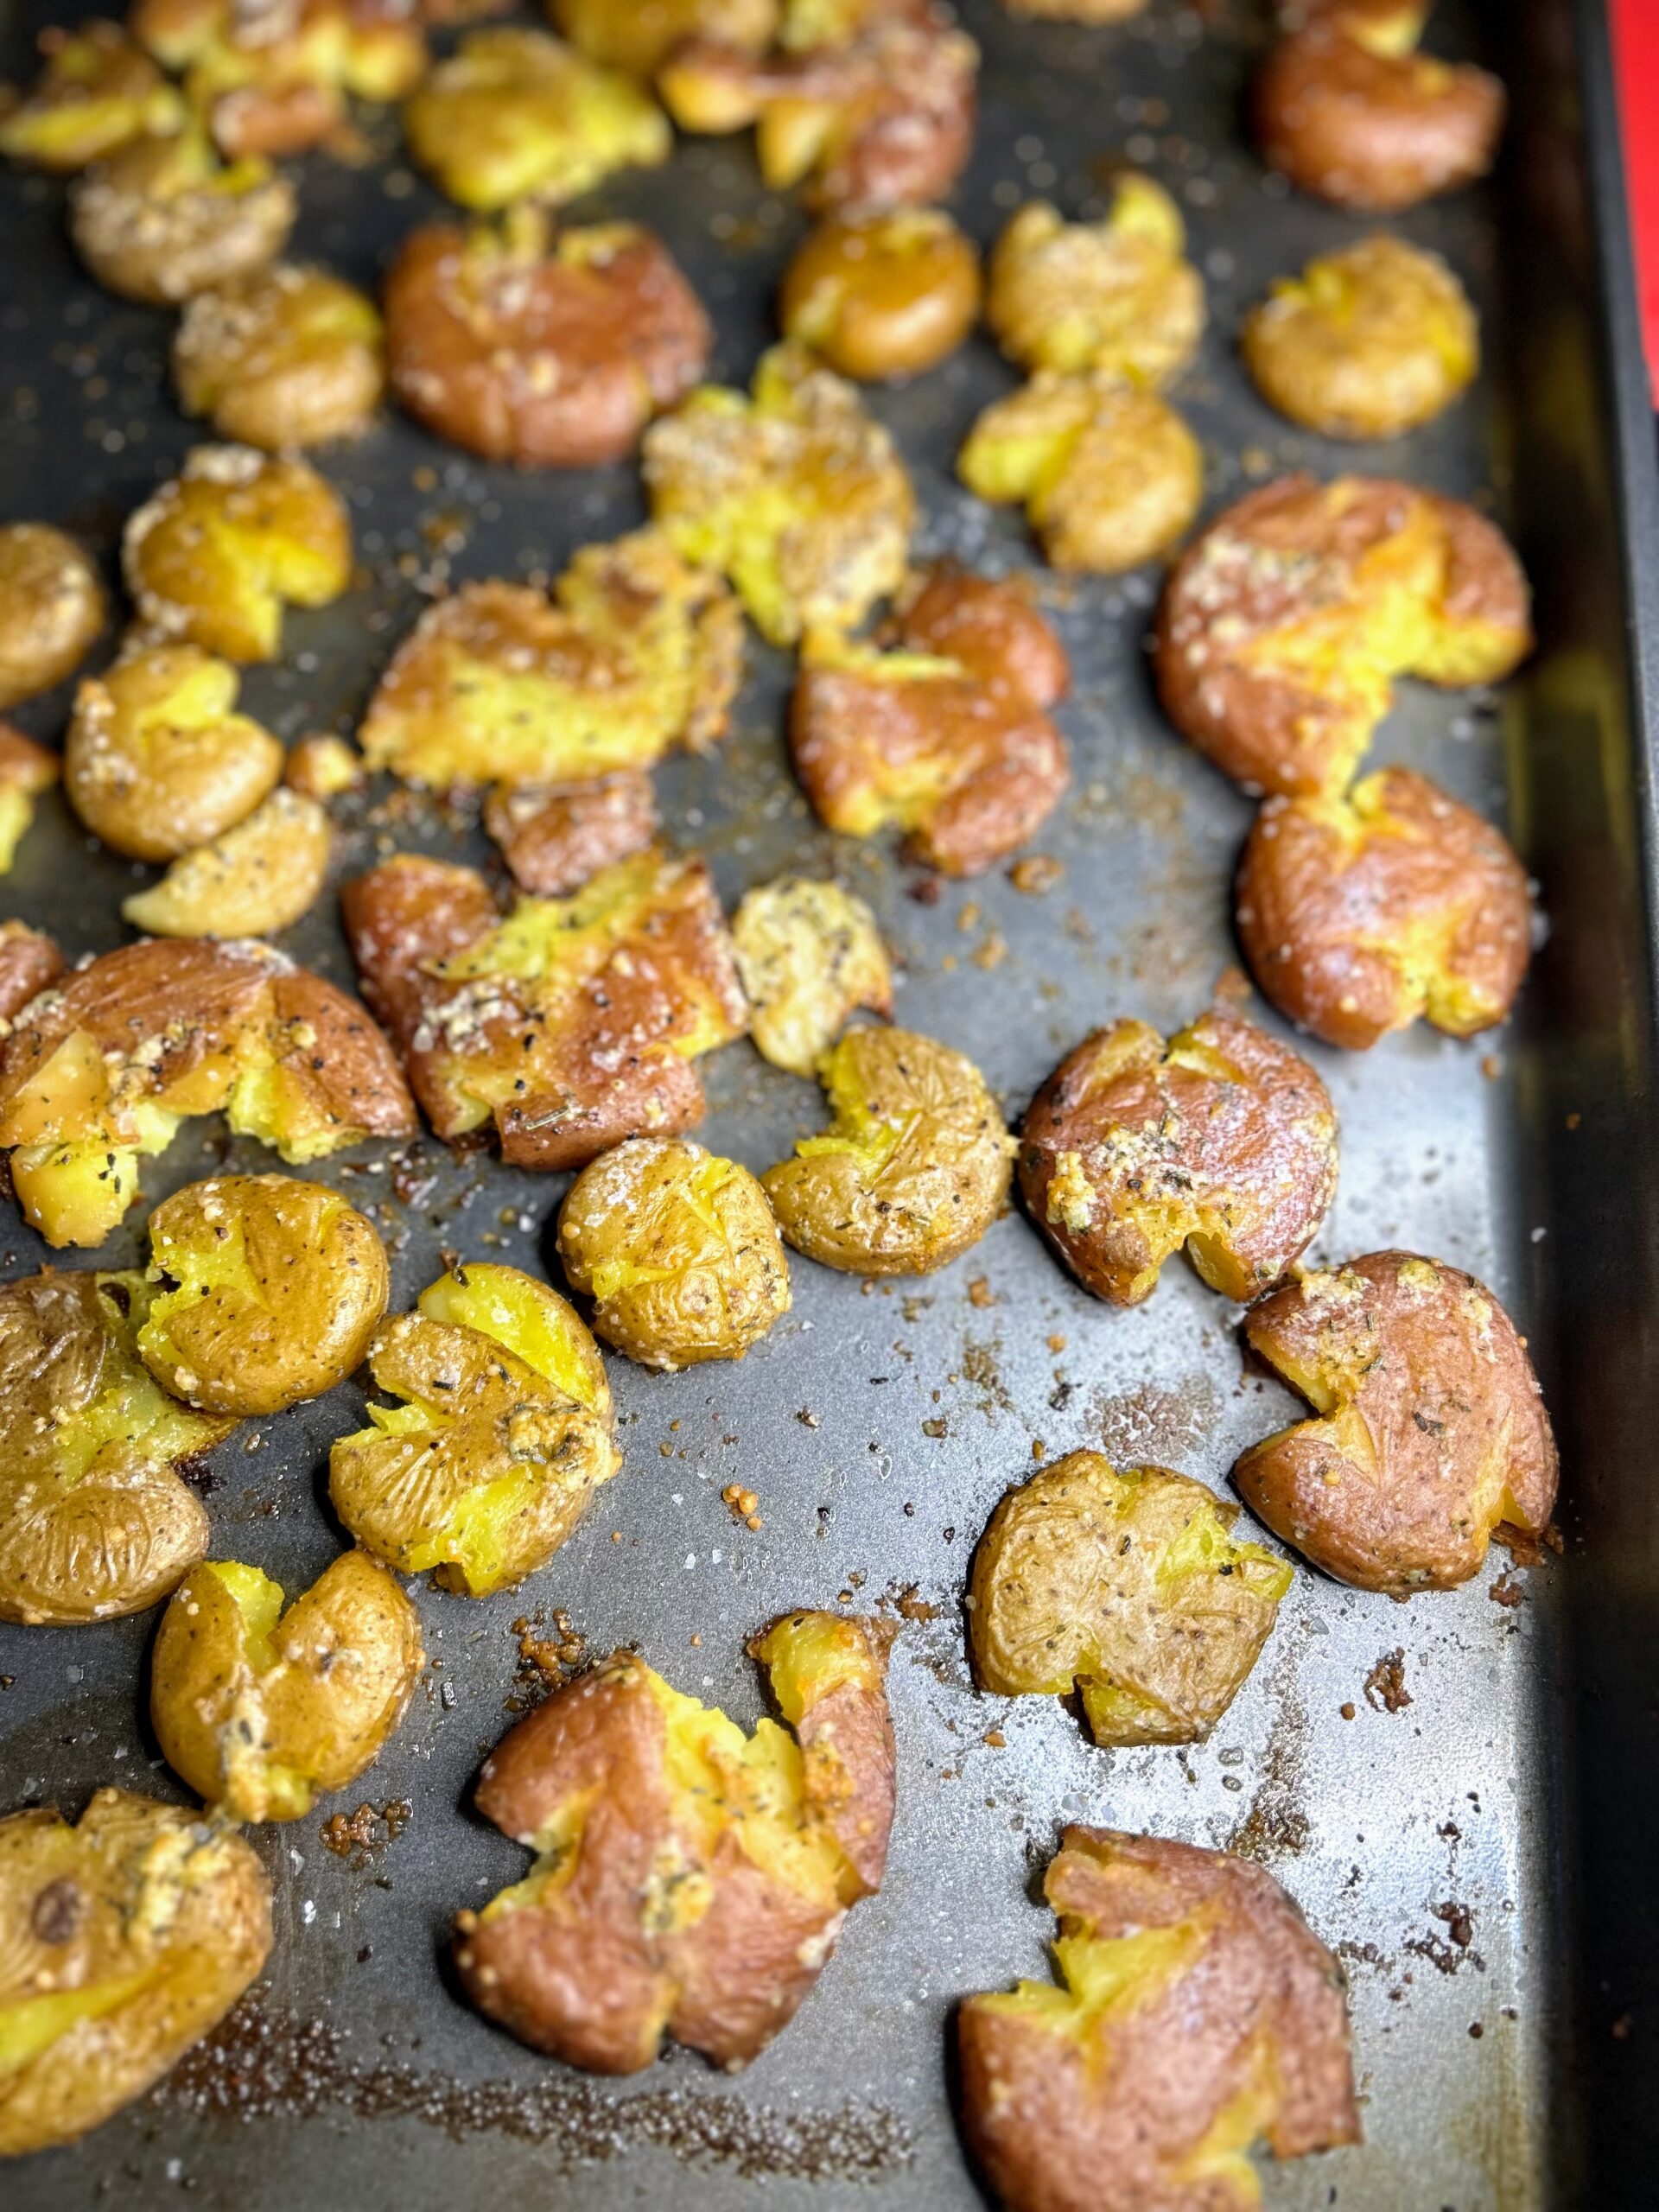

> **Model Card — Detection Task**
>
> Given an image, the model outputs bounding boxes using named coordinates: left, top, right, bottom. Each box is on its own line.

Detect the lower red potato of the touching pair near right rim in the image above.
left=1234, top=767, right=1533, bottom=1053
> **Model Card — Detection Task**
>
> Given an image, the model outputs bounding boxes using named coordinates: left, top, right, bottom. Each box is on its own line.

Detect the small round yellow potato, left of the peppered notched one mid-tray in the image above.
left=560, top=1137, right=790, bottom=1370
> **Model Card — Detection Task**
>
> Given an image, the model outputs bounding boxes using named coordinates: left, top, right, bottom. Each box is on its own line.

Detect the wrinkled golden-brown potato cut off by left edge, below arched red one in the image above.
left=0, top=1269, right=237, bottom=1618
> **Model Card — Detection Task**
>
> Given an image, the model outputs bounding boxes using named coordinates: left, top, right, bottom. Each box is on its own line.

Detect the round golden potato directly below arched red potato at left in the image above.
left=137, top=1174, right=390, bottom=1415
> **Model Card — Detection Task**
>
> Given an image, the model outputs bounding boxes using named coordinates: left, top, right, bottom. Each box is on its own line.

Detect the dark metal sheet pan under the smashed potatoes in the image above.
left=0, top=0, right=1659, bottom=2212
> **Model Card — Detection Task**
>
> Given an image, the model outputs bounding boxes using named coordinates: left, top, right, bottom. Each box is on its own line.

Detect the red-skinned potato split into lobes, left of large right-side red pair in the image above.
left=790, top=569, right=1071, bottom=876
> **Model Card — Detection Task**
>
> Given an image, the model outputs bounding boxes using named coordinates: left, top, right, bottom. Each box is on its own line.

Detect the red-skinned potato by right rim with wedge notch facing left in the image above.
left=1232, top=1252, right=1557, bottom=1597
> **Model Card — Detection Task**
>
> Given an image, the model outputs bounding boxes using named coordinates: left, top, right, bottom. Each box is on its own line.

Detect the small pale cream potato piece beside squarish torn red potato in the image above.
left=732, top=876, right=893, bottom=1075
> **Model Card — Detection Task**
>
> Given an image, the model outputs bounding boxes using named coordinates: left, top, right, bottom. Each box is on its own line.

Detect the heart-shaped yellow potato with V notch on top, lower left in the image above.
left=150, top=1551, right=425, bottom=1821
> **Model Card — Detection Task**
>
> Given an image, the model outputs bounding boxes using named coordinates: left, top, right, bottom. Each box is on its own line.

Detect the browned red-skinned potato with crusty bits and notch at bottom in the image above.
left=1020, top=1007, right=1336, bottom=1305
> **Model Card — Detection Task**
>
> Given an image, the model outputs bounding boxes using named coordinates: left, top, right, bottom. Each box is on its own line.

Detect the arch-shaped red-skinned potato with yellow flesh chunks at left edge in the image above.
left=0, top=938, right=416, bottom=1245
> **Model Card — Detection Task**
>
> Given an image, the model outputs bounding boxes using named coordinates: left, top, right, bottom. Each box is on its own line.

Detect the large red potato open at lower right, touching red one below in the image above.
left=1153, top=475, right=1533, bottom=797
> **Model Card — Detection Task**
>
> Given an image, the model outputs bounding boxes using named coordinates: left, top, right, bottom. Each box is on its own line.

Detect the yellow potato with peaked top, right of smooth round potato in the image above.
left=984, top=170, right=1204, bottom=390
